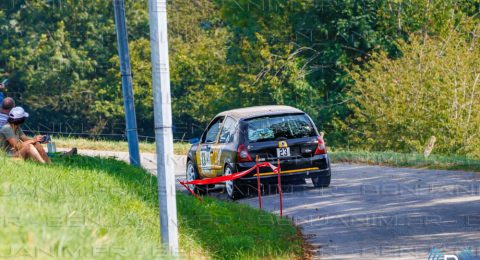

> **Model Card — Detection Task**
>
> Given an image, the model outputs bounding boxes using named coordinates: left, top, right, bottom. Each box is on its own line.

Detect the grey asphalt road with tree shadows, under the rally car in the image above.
left=69, top=151, right=480, bottom=259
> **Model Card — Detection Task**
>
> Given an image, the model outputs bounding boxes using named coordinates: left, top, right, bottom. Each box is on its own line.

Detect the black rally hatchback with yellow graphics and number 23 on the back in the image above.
left=186, top=106, right=331, bottom=199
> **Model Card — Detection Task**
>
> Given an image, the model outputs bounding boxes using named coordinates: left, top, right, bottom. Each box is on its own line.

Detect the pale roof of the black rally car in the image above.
left=217, top=105, right=304, bottom=119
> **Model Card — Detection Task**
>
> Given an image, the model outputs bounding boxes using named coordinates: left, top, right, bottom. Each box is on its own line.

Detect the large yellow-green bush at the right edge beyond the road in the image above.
left=344, top=30, right=480, bottom=157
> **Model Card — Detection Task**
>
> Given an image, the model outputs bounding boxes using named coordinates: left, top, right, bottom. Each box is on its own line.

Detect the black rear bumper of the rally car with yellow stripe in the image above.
left=236, top=154, right=331, bottom=183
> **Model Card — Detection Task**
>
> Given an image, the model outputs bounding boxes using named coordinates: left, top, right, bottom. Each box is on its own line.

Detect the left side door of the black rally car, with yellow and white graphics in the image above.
left=196, top=116, right=224, bottom=178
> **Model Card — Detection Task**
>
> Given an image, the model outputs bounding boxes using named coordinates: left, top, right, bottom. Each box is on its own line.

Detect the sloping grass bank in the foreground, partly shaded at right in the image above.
left=0, top=157, right=303, bottom=259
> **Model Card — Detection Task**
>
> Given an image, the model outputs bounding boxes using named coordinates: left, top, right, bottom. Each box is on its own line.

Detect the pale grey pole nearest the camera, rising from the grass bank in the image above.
left=148, top=0, right=178, bottom=255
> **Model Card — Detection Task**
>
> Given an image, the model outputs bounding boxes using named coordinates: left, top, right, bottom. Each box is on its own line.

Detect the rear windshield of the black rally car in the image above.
left=246, top=114, right=316, bottom=142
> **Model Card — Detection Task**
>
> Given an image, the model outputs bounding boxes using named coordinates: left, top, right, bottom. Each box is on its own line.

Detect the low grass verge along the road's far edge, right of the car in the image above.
left=329, top=151, right=480, bottom=172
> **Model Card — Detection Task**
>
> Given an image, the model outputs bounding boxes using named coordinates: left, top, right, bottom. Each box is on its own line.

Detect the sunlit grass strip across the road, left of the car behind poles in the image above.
left=53, top=137, right=191, bottom=155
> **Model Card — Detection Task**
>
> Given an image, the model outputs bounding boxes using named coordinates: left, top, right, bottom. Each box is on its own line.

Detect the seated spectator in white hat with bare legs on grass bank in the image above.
left=0, top=107, right=50, bottom=163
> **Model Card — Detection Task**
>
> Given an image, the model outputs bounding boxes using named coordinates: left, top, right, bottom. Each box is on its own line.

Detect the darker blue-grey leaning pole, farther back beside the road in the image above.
left=113, top=0, right=141, bottom=167
